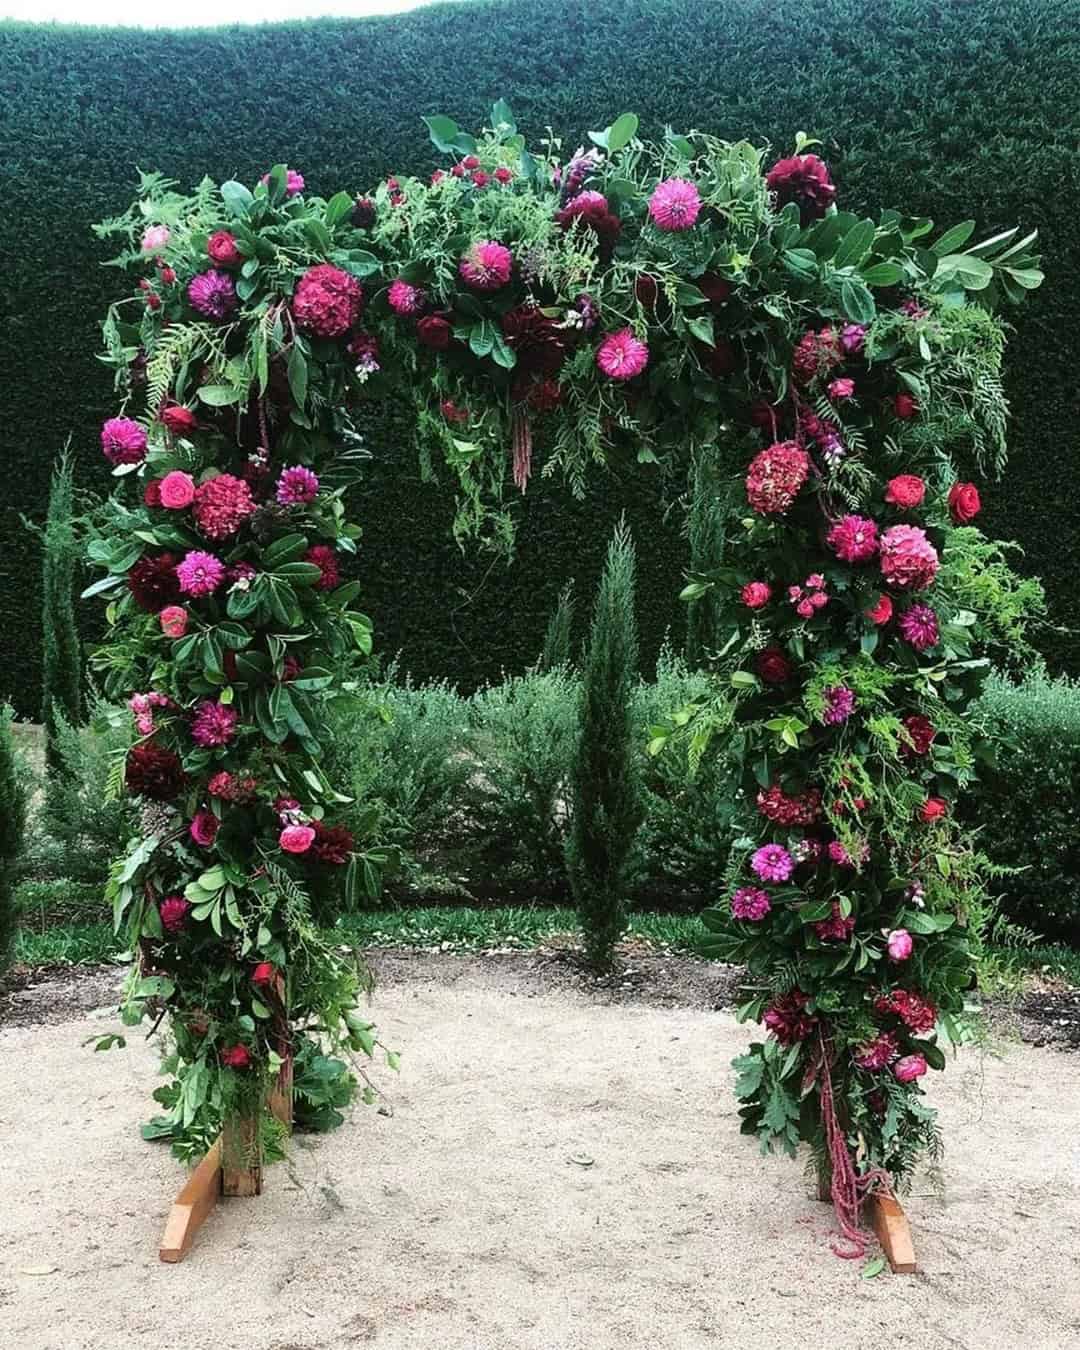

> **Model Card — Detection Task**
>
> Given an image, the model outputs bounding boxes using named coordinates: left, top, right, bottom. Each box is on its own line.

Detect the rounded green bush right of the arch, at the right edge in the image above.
left=968, top=672, right=1080, bottom=944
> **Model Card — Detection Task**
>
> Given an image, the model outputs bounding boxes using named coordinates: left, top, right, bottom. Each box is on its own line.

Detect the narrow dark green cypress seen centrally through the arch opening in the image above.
left=567, top=521, right=644, bottom=969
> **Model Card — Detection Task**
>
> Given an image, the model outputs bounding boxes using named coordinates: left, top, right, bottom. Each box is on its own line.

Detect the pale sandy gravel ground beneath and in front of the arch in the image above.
left=0, top=961, right=1080, bottom=1350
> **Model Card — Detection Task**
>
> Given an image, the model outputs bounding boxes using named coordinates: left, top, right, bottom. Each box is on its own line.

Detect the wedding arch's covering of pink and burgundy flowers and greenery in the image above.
left=88, top=103, right=1041, bottom=1249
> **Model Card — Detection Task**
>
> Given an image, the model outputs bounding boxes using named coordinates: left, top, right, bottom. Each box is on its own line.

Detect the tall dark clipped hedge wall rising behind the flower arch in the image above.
left=0, top=0, right=1080, bottom=711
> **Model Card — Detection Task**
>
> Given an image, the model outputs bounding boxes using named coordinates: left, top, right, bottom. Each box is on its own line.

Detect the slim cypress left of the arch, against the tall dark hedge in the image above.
left=42, top=450, right=82, bottom=778
